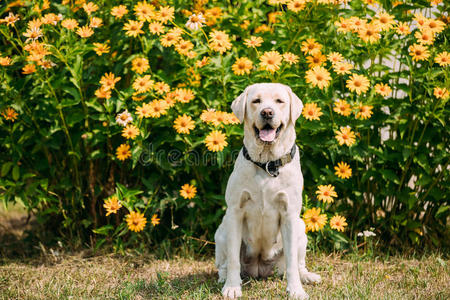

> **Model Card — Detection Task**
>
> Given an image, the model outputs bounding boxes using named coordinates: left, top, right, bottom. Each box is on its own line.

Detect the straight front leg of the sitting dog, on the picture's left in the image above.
left=222, top=207, right=243, bottom=299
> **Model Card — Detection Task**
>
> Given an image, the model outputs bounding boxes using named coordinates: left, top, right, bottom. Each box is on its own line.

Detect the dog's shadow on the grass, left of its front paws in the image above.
left=118, top=271, right=222, bottom=299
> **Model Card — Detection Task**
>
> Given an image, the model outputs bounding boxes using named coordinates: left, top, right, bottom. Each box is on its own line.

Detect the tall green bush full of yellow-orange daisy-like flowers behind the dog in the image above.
left=0, top=0, right=450, bottom=250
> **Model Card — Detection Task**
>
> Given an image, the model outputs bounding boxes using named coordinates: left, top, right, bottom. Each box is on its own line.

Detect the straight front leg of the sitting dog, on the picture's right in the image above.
left=280, top=196, right=308, bottom=299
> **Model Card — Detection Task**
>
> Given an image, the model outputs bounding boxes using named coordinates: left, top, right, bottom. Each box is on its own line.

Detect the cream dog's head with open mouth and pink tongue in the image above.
left=231, top=83, right=303, bottom=144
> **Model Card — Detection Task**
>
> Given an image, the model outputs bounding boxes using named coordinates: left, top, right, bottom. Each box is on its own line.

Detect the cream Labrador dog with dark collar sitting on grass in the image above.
left=214, top=83, right=320, bottom=299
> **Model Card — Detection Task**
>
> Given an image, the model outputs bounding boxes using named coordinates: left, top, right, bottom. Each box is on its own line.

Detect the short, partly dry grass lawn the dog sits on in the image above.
left=0, top=253, right=450, bottom=299
